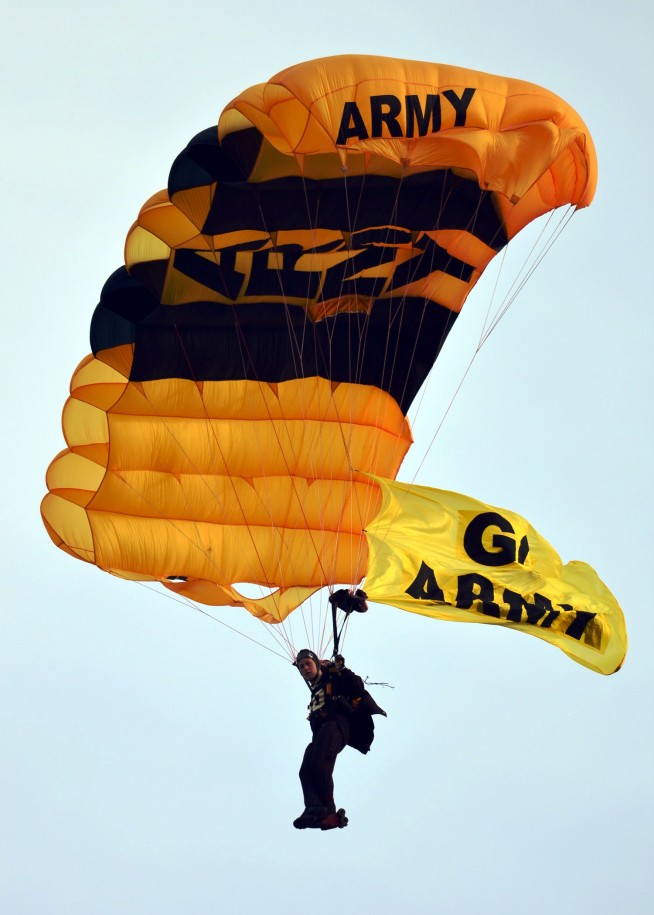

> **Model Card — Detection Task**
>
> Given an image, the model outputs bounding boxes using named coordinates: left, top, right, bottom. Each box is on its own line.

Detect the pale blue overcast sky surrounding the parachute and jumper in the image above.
left=0, top=0, right=654, bottom=915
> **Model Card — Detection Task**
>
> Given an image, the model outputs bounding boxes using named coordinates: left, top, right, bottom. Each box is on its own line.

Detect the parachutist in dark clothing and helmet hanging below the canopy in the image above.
left=293, top=648, right=386, bottom=829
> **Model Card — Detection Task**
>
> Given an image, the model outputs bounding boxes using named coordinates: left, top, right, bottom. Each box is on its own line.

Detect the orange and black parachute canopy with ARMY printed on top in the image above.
left=42, top=56, right=596, bottom=622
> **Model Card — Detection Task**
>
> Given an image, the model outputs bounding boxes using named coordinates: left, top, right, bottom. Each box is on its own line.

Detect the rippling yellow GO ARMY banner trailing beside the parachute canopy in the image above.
left=365, top=477, right=627, bottom=674
